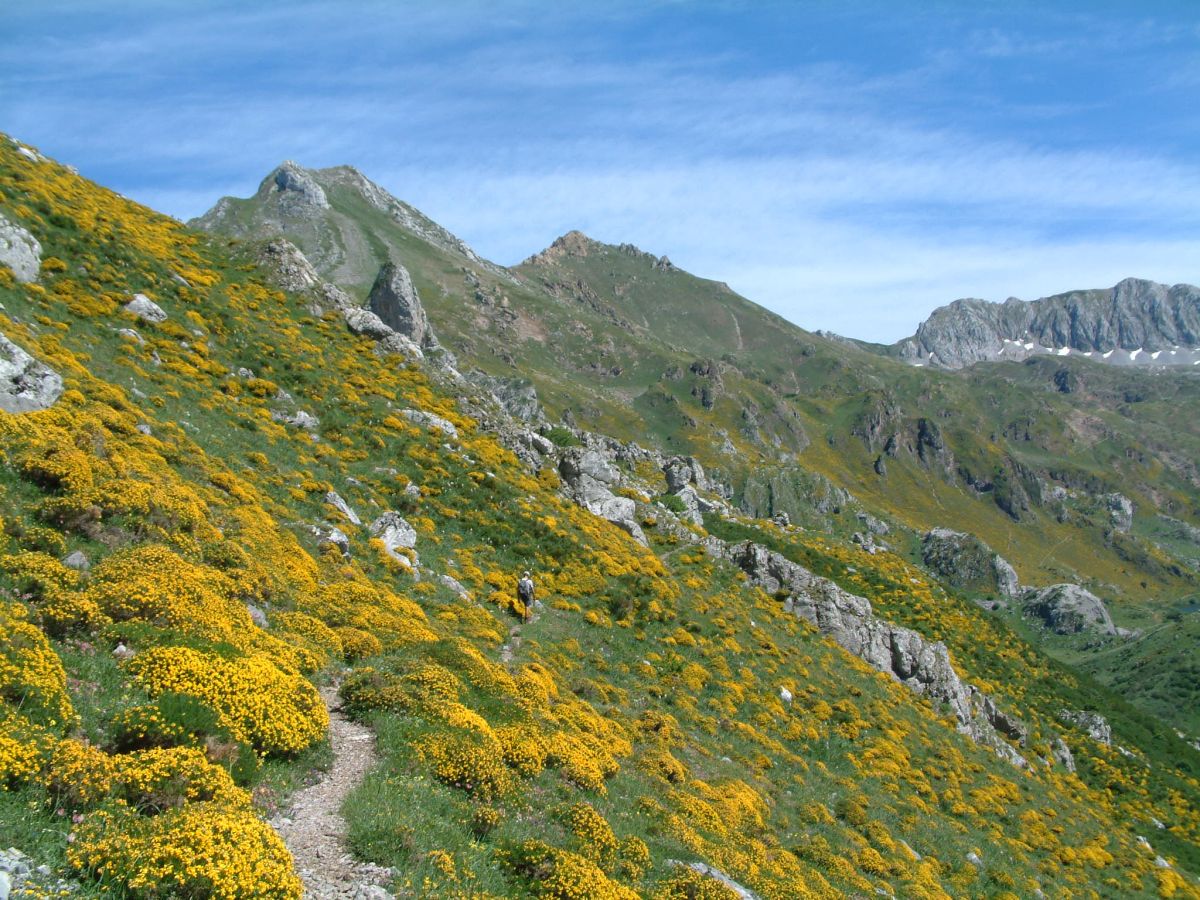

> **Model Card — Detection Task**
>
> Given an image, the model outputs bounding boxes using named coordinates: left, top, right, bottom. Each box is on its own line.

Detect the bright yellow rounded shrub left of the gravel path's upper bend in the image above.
left=130, top=647, right=329, bottom=754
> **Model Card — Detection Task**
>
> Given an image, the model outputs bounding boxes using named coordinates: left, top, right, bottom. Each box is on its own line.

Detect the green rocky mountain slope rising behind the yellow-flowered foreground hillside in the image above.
left=192, top=164, right=1200, bottom=748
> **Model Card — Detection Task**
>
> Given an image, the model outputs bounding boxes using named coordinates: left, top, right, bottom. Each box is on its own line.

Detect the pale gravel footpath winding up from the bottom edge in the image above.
left=271, top=688, right=391, bottom=900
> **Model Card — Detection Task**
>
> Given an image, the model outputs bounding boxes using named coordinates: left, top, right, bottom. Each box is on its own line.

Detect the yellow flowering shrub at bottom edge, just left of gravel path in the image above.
left=67, top=802, right=301, bottom=900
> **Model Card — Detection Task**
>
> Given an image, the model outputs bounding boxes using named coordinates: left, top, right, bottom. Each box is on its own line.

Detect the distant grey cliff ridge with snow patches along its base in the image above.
left=894, top=278, right=1200, bottom=368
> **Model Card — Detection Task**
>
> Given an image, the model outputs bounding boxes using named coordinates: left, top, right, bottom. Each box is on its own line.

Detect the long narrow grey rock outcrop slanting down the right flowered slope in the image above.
left=704, top=540, right=1027, bottom=767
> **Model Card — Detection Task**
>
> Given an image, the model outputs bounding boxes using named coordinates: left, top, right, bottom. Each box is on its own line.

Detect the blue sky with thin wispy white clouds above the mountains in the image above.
left=0, top=0, right=1200, bottom=341
